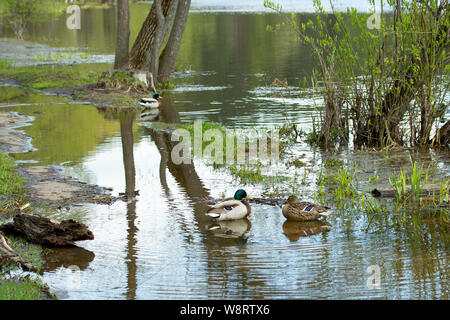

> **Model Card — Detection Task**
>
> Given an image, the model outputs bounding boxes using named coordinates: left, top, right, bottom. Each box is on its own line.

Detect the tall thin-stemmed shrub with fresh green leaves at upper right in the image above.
left=264, top=0, right=450, bottom=148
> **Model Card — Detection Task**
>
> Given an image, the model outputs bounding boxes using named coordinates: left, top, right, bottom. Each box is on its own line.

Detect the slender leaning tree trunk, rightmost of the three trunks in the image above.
left=158, top=0, right=191, bottom=82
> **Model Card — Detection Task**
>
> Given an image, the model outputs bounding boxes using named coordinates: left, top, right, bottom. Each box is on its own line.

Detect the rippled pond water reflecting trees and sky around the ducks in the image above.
left=0, top=5, right=450, bottom=299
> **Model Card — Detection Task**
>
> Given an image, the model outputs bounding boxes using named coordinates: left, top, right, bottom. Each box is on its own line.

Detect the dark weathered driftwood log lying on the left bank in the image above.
left=0, top=213, right=94, bottom=247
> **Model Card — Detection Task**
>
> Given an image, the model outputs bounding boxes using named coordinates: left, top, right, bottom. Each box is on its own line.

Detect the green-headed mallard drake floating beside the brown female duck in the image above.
left=206, top=189, right=251, bottom=221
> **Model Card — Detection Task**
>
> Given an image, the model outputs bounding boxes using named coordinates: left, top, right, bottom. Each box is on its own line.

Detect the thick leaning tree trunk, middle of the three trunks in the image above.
left=128, top=0, right=178, bottom=74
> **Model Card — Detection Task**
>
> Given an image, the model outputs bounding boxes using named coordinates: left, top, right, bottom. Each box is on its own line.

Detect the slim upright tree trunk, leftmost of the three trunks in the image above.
left=114, top=0, right=130, bottom=69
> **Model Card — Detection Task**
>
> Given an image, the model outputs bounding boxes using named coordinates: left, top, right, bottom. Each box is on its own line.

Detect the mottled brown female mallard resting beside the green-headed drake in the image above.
left=282, top=196, right=332, bottom=221
